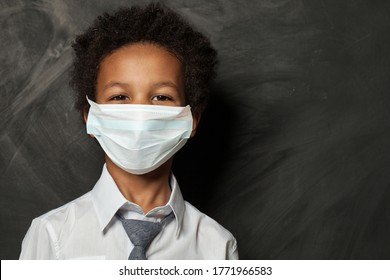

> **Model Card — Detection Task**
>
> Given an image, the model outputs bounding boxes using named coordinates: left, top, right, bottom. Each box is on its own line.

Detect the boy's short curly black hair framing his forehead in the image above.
left=70, top=3, right=217, bottom=115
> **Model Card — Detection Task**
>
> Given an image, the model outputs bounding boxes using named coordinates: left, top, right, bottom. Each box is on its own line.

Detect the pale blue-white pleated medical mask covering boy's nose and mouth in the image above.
left=87, top=99, right=192, bottom=174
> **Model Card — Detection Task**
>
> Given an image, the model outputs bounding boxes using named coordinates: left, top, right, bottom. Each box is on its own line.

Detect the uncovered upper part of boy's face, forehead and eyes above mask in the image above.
left=96, top=43, right=186, bottom=106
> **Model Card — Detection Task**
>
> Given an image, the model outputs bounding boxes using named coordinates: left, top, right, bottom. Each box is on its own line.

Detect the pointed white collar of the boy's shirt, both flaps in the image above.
left=91, top=164, right=184, bottom=236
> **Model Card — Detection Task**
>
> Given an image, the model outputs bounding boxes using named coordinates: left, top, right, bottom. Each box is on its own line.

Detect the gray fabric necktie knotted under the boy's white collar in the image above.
left=117, top=211, right=175, bottom=260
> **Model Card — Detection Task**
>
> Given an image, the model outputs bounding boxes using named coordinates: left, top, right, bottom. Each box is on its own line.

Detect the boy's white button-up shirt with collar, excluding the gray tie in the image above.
left=20, top=165, right=238, bottom=260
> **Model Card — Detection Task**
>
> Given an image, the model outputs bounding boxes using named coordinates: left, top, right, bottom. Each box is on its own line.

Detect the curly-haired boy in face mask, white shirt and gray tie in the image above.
left=20, top=4, right=238, bottom=259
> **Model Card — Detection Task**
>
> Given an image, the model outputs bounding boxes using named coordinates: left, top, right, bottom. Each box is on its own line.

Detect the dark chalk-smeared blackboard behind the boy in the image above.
left=0, top=0, right=390, bottom=259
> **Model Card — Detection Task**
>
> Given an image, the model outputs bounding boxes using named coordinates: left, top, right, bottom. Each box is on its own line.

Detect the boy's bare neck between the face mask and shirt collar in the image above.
left=106, top=156, right=172, bottom=214
